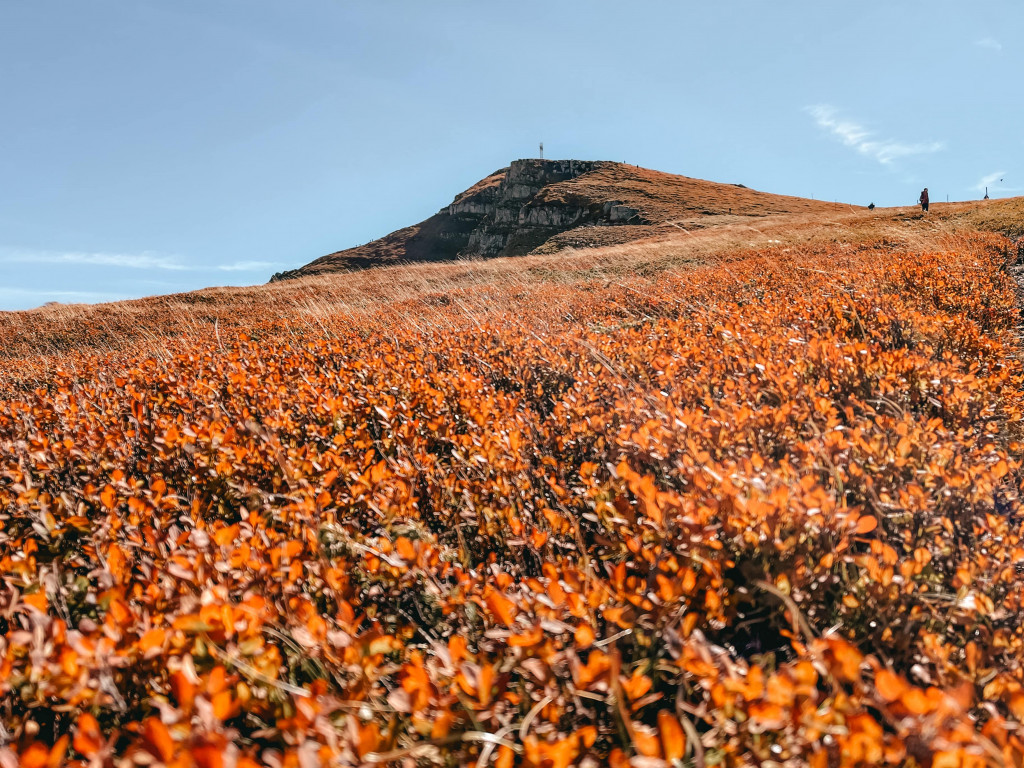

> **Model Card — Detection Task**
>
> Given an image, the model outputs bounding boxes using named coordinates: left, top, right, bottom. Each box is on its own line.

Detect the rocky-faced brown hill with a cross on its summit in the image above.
left=272, top=160, right=849, bottom=281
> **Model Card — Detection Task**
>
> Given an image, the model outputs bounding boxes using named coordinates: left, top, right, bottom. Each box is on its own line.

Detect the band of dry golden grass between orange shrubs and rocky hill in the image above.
left=0, top=201, right=1024, bottom=370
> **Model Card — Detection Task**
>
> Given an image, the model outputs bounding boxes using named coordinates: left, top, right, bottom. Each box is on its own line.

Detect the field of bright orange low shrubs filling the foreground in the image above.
left=0, top=236, right=1024, bottom=768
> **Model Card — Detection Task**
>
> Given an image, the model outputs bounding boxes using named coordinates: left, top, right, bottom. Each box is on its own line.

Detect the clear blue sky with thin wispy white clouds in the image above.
left=0, top=0, right=1024, bottom=309
